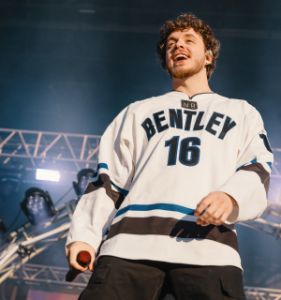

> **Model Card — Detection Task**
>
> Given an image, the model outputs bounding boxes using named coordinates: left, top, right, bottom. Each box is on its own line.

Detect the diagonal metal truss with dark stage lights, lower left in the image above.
left=0, top=169, right=94, bottom=284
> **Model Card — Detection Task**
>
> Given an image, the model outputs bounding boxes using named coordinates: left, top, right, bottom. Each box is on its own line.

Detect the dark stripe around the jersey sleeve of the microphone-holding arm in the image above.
left=84, top=174, right=125, bottom=209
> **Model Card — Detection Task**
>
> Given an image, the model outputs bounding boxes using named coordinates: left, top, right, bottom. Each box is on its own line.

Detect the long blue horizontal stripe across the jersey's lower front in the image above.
left=115, top=203, right=195, bottom=218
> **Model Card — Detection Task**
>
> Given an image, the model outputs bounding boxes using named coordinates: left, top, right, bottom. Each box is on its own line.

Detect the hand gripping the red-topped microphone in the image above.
left=65, top=242, right=96, bottom=273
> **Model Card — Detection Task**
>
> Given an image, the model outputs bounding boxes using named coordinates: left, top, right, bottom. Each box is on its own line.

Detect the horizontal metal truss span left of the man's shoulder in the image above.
left=0, top=128, right=100, bottom=173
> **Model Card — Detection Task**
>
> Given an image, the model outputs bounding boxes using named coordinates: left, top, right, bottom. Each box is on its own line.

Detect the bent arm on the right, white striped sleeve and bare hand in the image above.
left=195, top=107, right=273, bottom=226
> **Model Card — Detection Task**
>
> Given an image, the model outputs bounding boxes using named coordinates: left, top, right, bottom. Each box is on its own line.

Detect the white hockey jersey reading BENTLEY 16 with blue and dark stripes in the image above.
left=67, top=91, right=273, bottom=268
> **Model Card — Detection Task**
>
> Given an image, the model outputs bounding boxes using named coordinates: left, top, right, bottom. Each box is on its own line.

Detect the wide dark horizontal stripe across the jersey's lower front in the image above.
left=107, top=217, right=238, bottom=252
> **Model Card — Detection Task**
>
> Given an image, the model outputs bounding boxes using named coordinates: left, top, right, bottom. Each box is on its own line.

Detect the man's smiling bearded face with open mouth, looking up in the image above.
left=166, top=28, right=209, bottom=79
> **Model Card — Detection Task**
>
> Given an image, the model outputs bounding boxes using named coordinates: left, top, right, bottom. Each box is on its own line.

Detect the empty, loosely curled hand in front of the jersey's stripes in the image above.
left=194, top=192, right=237, bottom=226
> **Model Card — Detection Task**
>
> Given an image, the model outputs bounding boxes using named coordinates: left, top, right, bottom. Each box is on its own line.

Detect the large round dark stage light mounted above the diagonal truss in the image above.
left=20, top=188, right=55, bottom=225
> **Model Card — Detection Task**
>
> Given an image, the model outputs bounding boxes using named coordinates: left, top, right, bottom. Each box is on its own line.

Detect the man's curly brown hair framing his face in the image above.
left=157, top=14, right=220, bottom=80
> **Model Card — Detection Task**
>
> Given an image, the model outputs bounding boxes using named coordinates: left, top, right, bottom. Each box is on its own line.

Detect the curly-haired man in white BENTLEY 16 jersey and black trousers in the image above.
left=66, top=14, right=273, bottom=300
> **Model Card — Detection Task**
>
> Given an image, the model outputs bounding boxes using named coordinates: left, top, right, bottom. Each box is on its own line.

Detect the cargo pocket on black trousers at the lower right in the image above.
left=220, top=268, right=247, bottom=300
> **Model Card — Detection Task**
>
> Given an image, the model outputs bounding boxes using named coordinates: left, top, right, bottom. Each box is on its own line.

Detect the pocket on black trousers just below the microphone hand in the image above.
left=79, top=265, right=109, bottom=300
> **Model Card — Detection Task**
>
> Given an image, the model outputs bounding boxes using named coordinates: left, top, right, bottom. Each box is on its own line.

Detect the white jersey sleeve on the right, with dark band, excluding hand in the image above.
left=215, top=106, right=273, bottom=223
